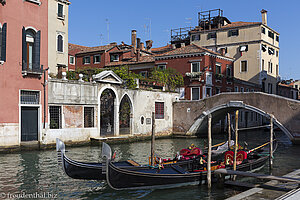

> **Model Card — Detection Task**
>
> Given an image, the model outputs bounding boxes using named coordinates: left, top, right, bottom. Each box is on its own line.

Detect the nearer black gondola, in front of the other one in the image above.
left=103, top=141, right=276, bottom=190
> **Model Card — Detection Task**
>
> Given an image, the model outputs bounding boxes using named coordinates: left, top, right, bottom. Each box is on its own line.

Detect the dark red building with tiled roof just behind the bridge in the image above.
left=155, top=44, right=233, bottom=100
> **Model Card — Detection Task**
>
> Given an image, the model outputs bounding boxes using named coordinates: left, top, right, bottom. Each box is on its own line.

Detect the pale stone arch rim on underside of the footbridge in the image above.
left=187, top=101, right=293, bottom=140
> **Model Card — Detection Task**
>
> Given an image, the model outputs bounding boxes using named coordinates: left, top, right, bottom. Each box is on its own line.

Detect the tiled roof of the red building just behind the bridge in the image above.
left=156, top=43, right=233, bottom=59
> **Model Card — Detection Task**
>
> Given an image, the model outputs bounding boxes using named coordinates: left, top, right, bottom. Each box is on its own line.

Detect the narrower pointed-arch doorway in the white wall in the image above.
left=119, top=95, right=132, bottom=135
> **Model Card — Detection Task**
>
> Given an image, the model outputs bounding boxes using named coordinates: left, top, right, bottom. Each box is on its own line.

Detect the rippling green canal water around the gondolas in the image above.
left=0, top=131, right=300, bottom=200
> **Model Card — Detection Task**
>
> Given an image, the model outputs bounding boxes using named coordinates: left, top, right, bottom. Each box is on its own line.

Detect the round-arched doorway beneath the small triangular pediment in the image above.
left=100, top=89, right=116, bottom=136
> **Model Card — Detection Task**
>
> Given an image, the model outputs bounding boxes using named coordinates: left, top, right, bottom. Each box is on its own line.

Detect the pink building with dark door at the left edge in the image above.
left=0, top=0, right=48, bottom=146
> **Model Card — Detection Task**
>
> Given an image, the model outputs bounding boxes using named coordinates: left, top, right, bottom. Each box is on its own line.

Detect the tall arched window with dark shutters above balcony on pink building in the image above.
left=22, top=27, right=41, bottom=72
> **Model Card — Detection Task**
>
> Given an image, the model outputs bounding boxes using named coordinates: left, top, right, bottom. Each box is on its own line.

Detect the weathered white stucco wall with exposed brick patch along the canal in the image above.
left=42, top=79, right=179, bottom=144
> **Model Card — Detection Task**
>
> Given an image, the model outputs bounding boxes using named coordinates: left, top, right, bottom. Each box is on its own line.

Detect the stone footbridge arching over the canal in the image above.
left=173, top=92, right=300, bottom=143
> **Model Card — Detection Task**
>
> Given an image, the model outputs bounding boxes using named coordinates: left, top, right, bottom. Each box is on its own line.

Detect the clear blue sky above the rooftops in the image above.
left=69, top=0, right=300, bottom=79
